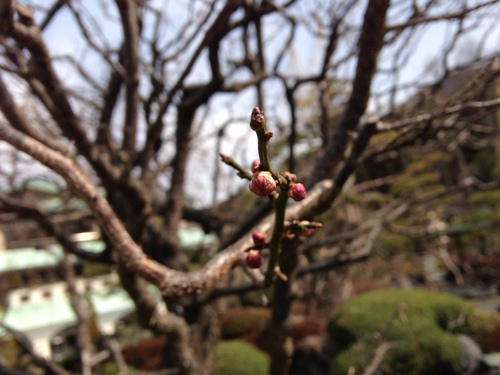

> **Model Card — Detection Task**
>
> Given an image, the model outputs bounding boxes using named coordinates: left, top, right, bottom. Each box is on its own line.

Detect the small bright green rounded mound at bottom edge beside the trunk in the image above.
left=214, top=340, right=269, bottom=375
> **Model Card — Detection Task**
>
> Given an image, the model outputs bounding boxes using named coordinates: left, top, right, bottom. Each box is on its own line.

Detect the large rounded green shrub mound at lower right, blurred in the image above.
left=328, top=290, right=473, bottom=375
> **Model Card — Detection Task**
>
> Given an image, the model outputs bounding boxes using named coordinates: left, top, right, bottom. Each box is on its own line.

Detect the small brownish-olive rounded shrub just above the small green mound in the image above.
left=222, top=307, right=269, bottom=339
